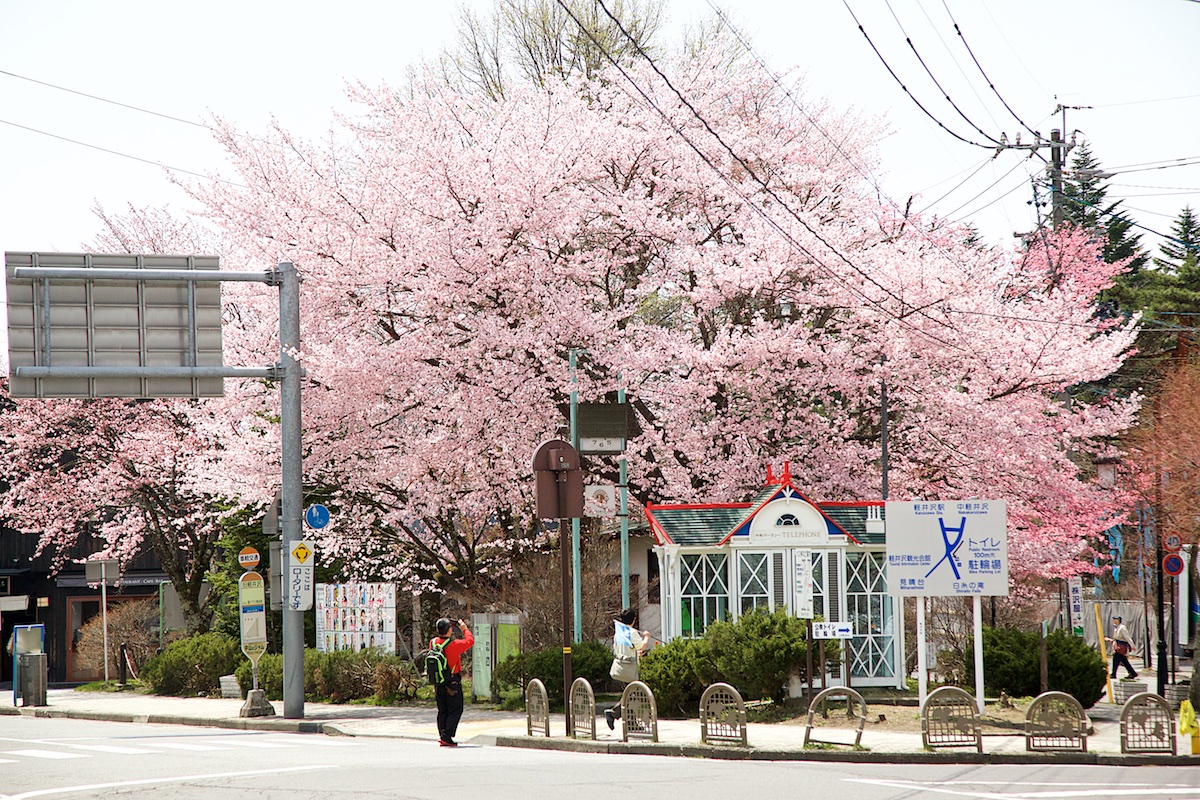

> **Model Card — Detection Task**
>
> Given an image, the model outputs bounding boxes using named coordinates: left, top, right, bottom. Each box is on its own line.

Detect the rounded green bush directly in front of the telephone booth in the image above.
left=694, top=609, right=840, bottom=705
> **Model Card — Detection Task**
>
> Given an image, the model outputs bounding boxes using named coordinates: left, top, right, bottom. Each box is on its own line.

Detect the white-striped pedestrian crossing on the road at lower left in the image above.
left=0, top=734, right=358, bottom=764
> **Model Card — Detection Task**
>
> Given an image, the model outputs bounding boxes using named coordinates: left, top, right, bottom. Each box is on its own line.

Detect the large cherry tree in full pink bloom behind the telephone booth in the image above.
left=11, top=40, right=1134, bottom=604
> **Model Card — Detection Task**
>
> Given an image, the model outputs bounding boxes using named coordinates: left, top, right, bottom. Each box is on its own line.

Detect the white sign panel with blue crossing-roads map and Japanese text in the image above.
left=887, top=500, right=1008, bottom=597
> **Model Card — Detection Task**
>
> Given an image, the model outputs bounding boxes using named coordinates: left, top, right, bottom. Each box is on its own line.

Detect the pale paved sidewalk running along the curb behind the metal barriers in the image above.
left=0, top=690, right=1200, bottom=765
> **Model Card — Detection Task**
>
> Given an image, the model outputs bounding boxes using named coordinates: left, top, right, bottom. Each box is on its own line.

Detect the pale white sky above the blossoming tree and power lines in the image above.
left=0, top=0, right=1200, bottom=369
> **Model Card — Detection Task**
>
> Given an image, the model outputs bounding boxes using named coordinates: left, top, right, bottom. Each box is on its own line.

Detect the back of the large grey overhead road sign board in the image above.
left=5, top=253, right=224, bottom=397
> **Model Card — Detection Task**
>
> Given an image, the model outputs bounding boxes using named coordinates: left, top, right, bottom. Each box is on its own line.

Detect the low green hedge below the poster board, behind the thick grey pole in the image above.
left=238, top=649, right=420, bottom=703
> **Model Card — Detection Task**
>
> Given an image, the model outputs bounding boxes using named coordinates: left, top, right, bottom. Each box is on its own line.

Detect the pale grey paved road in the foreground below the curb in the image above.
left=0, top=716, right=1200, bottom=800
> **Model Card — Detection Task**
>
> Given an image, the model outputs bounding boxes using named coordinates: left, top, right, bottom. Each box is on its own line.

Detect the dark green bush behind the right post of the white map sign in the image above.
left=966, top=627, right=1105, bottom=709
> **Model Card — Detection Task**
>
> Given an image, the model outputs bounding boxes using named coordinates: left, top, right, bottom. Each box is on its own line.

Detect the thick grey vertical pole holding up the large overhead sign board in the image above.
left=277, top=261, right=304, bottom=720
